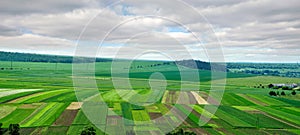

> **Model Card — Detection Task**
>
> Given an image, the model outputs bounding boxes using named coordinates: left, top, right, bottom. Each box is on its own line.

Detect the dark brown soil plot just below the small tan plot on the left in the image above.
left=53, top=110, right=78, bottom=126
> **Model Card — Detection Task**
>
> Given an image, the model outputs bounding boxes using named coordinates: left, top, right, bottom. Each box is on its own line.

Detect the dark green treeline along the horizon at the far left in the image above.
left=0, top=52, right=112, bottom=63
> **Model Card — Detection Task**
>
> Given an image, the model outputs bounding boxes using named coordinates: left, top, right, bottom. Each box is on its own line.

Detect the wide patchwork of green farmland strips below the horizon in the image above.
left=0, top=61, right=300, bottom=134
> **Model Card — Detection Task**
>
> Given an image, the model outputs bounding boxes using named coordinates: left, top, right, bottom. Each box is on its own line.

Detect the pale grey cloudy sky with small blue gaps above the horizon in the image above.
left=0, top=0, right=300, bottom=62
